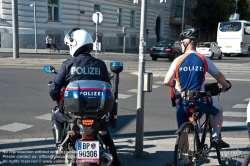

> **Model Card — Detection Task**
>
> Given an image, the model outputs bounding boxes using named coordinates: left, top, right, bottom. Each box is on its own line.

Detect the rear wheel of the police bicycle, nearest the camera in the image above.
left=174, top=122, right=199, bottom=166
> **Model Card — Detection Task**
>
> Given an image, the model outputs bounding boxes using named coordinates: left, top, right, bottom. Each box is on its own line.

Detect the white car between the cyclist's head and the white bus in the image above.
left=196, top=42, right=222, bottom=59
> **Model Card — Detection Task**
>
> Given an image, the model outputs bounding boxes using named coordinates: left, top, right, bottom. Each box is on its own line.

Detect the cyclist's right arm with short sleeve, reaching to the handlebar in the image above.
left=206, top=58, right=229, bottom=91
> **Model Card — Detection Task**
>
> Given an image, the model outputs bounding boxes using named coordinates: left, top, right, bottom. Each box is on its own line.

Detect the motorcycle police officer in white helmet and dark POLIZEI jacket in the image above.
left=49, top=28, right=121, bottom=166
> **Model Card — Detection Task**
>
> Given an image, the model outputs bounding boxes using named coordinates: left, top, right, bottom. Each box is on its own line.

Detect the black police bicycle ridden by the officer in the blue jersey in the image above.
left=174, top=81, right=231, bottom=166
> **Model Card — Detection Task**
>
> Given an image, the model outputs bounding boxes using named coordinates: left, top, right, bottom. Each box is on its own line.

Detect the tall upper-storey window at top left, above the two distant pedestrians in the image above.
left=48, top=0, right=59, bottom=21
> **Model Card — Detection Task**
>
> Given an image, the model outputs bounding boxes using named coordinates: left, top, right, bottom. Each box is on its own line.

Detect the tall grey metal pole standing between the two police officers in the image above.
left=135, top=0, right=147, bottom=157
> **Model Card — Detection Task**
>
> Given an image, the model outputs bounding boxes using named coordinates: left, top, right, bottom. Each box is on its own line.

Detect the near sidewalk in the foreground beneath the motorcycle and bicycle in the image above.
left=0, top=135, right=250, bottom=166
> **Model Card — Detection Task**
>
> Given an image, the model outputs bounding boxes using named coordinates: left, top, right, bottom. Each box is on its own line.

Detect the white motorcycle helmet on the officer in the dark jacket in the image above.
left=64, top=28, right=93, bottom=57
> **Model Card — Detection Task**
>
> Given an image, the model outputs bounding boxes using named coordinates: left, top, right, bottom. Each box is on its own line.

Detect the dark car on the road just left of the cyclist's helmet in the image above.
left=149, top=40, right=182, bottom=61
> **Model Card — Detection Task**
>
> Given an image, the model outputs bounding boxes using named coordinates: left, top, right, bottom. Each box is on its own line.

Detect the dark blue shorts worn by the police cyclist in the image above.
left=176, top=99, right=221, bottom=128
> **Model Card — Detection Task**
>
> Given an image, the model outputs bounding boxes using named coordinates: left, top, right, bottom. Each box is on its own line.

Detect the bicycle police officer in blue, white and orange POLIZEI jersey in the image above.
left=164, top=28, right=229, bottom=148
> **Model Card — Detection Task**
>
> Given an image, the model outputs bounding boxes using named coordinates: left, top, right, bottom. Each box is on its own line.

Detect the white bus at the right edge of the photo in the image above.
left=217, top=20, right=250, bottom=56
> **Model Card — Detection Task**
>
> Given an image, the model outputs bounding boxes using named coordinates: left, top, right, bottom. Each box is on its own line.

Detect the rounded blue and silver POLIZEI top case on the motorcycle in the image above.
left=64, top=80, right=114, bottom=113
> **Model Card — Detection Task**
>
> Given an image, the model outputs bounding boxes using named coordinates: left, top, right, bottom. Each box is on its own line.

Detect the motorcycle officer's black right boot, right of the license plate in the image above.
left=100, top=132, right=121, bottom=166
